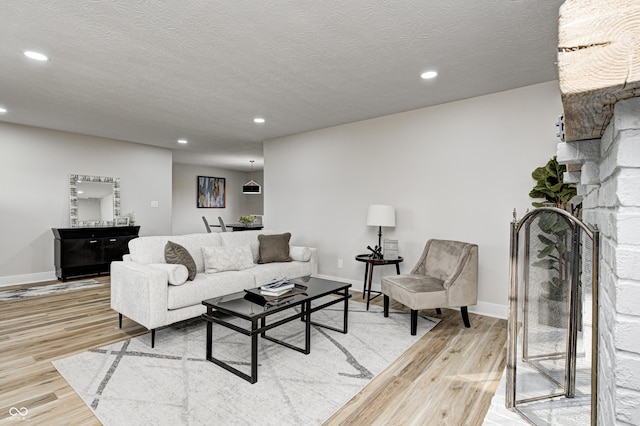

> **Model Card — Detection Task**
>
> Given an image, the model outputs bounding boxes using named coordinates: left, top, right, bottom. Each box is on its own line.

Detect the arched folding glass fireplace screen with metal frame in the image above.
left=506, top=207, right=599, bottom=425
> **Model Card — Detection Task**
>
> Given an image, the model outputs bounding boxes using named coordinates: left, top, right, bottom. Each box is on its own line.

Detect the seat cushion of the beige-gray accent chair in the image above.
left=382, top=274, right=447, bottom=310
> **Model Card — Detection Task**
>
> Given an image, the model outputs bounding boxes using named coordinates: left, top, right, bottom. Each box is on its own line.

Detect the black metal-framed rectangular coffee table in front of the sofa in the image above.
left=202, top=278, right=351, bottom=383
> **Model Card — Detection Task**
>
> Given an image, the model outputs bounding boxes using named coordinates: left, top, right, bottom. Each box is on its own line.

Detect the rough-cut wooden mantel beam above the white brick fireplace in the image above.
left=558, top=0, right=640, bottom=141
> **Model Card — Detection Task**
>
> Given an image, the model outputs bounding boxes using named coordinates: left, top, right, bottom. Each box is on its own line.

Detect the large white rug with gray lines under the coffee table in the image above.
left=53, top=299, right=439, bottom=425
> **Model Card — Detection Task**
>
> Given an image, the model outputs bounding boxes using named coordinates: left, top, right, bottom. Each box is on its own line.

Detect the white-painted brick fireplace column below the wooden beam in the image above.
left=557, top=97, right=640, bottom=425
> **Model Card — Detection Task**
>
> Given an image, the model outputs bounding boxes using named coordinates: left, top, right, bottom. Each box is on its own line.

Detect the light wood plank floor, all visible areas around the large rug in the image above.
left=0, top=277, right=506, bottom=425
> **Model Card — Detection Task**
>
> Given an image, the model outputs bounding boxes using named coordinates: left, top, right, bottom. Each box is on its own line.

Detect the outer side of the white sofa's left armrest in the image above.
left=111, top=261, right=169, bottom=330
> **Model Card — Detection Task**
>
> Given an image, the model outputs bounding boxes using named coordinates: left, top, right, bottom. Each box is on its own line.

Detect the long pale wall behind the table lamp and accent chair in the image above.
left=264, top=82, right=562, bottom=317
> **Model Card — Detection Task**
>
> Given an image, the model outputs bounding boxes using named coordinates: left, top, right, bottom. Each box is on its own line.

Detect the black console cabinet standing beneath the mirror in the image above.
left=51, top=226, right=140, bottom=281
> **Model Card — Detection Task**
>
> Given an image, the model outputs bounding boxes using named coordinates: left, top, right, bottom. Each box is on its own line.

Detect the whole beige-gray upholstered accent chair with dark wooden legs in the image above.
left=382, top=240, right=478, bottom=335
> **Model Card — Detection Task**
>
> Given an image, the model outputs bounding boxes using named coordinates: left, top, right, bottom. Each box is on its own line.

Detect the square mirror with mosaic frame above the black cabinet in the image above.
left=69, top=175, right=120, bottom=228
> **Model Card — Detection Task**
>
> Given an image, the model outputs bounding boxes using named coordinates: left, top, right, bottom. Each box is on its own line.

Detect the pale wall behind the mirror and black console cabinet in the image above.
left=0, top=122, right=172, bottom=285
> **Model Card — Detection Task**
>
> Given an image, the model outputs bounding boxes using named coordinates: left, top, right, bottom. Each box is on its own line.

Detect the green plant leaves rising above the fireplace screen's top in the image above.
left=529, top=157, right=576, bottom=210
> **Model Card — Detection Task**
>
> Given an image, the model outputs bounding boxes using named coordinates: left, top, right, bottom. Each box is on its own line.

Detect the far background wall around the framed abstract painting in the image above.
left=173, top=163, right=264, bottom=235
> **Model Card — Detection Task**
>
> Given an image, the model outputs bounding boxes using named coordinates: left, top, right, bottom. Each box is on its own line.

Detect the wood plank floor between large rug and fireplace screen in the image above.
left=325, top=293, right=507, bottom=425
